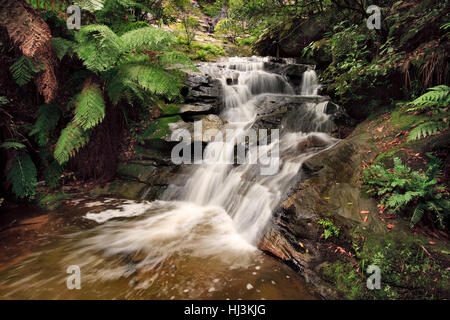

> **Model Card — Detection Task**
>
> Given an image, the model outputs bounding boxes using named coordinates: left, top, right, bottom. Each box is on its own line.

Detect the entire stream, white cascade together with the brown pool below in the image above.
left=0, top=57, right=338, bottom=299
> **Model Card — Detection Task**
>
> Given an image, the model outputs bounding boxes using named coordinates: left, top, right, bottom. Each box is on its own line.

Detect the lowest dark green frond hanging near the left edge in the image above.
left=7, top=152, right=37, bottom=199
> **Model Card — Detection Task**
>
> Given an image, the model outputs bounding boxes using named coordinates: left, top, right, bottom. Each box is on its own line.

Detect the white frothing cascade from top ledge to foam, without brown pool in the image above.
left=81, top=57, right=336, bottom=266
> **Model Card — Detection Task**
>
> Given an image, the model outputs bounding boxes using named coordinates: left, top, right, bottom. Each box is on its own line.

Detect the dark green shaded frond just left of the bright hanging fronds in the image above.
left=30, top=104, right=61, bottom=147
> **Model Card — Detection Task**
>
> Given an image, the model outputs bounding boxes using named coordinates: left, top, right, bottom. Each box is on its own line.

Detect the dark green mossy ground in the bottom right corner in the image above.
left=321, top=232, right=450, bottom=299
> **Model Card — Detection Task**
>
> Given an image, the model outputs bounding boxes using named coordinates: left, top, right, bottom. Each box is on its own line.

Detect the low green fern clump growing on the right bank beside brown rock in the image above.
left=364, top=154, right=450, bottom=227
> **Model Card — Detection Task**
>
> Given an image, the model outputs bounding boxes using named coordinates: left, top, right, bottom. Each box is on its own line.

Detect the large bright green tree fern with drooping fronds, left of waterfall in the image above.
left=54, top=25, right=195, bottom=164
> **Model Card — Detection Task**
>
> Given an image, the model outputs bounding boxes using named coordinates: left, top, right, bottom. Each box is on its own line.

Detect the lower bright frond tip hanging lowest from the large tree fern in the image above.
left=53, top=123, right=89, bottom=164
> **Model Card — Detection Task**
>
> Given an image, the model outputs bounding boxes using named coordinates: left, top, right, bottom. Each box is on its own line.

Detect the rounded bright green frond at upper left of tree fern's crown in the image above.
left=75, top=24, right=124, bottom=72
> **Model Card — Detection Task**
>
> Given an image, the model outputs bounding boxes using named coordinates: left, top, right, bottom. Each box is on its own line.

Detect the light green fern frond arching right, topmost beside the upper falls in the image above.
left=120, top=26, right=175, bottom=51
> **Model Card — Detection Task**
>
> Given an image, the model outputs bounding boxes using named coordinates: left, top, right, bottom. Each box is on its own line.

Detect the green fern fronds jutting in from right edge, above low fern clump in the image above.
left=406, top=85, right=450, bottom=141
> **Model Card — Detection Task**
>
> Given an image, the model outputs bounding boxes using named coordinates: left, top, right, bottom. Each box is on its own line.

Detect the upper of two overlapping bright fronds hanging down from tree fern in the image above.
left=73, top=79, right=105, bottom=130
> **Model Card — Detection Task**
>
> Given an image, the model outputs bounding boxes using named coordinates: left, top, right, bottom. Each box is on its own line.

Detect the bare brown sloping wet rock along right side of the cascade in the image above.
left=259, top=129, right=386, bottom=298
